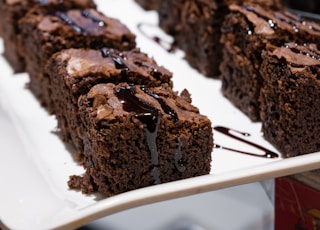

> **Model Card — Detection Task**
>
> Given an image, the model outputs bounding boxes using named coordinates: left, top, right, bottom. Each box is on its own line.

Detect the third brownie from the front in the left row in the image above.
left=20, top=9, right=136, bottom=112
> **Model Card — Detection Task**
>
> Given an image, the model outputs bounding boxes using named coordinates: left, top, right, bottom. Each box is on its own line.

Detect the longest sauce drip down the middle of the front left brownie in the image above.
left=115, top=87, right=161, bottom=184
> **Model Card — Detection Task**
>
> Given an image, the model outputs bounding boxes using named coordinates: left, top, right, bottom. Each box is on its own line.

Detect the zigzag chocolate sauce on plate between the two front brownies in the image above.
left=214, top=126, right=279, bottom=158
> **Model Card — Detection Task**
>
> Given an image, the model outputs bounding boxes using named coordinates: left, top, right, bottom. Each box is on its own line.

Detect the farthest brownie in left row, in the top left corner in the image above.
left=0, top=0, right=96, bottom=73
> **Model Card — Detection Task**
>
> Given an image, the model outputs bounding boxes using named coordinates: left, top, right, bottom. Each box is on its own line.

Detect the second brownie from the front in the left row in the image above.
left=46, top=48, right=172, bottom=156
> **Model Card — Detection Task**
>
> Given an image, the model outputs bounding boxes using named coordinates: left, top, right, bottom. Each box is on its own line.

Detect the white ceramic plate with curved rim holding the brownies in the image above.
left=0, top=0, right=320, bottom=229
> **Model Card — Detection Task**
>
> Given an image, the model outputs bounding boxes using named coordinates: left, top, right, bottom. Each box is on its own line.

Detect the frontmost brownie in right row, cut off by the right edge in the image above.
left=260, top=43, right=320, bottom=157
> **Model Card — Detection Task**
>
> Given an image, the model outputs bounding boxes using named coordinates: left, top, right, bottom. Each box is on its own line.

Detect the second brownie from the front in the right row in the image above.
left=220, top=5, right=320, bottom=121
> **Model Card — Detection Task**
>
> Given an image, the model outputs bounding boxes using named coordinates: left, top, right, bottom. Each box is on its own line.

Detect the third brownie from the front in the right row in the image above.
left=159, top=0, right=282, bottom=78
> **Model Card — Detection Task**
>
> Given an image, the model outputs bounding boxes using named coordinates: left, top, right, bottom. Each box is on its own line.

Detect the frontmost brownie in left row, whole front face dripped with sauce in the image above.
left=69, top=84, right=213, bottom=196
